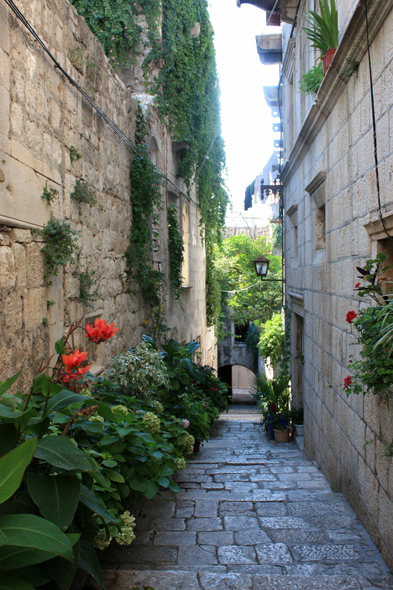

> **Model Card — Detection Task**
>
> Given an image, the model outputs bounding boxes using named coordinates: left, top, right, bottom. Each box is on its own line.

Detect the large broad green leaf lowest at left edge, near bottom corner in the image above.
left=0, top=514, right=72, bottom=561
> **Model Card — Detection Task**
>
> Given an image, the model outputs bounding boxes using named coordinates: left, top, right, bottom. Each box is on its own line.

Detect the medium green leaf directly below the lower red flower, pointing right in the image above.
left=34, top=436, right=91, bottom=471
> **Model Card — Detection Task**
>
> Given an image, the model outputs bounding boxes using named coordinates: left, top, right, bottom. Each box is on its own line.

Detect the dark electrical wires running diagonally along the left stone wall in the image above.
left=4, top=0, right=202, bottom=207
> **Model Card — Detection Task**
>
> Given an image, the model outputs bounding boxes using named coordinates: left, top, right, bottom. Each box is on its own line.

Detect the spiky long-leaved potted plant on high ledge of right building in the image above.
left=303, top=0, right=338, bottom=74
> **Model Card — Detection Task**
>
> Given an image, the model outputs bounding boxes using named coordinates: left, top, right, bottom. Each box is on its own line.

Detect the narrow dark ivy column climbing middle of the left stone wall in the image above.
left=126, top=106, right=167, bottom=336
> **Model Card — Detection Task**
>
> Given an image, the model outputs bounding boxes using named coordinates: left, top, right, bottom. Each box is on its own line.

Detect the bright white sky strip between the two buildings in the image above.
left=209, top=0, right=280, bottom=223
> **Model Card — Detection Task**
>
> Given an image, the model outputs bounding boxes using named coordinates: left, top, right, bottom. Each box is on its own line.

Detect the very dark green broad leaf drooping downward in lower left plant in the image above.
left=27, top=472, right=81, bottom=531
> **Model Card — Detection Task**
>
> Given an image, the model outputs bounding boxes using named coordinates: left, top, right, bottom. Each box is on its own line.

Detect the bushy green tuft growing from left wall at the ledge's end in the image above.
left=32, top=216, right=79, bottom=285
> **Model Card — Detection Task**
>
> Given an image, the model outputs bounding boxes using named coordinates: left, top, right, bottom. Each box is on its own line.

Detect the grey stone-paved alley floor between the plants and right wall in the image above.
left=99, top=406, right=393, bottom=590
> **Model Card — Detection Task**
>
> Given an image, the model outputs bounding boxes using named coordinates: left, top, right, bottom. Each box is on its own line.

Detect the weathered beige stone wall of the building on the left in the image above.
left=0, top=0, right=216, bottom=387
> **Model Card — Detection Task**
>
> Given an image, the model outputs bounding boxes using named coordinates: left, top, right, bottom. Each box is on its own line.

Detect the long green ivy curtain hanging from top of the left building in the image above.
left=71, top=0, right=229, bottom=332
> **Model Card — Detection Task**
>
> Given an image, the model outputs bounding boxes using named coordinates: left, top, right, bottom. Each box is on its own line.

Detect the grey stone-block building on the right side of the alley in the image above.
left=248, top=0, right=393, bottom=568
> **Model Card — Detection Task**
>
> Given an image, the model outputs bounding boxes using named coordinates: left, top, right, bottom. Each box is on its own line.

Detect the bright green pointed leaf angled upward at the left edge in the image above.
left=0, top=437, right=38, bottom=504
